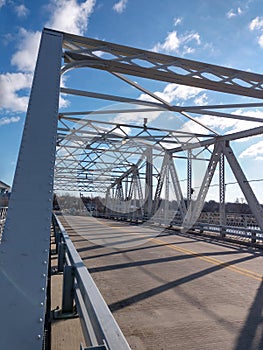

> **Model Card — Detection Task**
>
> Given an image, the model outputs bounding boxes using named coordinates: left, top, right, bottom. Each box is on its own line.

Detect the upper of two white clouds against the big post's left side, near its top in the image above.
left=11, top=28, right=41, bottom=72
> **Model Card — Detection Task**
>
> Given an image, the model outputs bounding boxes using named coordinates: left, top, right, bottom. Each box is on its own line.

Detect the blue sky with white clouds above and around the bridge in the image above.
left=0, top=0, right=263, bottom=202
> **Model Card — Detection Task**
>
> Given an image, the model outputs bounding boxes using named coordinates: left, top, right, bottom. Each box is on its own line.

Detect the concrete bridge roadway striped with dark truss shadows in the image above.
left=58, top=216, right=263, bottom=350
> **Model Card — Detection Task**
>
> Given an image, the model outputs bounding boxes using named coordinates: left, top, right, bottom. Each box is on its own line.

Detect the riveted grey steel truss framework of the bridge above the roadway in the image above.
left=0, top=29, right=263, bottom=349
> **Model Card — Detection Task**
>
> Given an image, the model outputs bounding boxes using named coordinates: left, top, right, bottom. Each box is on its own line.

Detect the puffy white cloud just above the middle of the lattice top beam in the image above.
left=152, top=30, right=201, bottom=53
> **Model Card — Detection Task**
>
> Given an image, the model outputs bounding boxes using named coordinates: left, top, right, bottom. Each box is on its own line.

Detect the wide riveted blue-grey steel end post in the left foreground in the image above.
left=0, top=29, right=63, bottom=350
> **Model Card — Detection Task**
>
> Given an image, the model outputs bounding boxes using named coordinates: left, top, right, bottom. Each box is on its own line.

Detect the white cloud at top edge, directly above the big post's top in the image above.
left=46, top=0, right=96, bottom=35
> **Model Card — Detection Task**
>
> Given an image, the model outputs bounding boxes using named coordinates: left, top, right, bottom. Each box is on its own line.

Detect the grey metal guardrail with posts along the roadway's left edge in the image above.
left=53, top=215, right=131, bottom=350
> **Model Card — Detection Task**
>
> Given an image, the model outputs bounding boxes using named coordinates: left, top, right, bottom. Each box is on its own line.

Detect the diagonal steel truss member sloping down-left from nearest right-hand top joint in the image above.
left=182, top=142, right=222, bottom=231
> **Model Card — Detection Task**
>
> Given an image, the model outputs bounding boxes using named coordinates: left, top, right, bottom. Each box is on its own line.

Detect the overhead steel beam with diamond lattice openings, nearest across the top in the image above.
left=64, top=30, right=263, bottom=98
